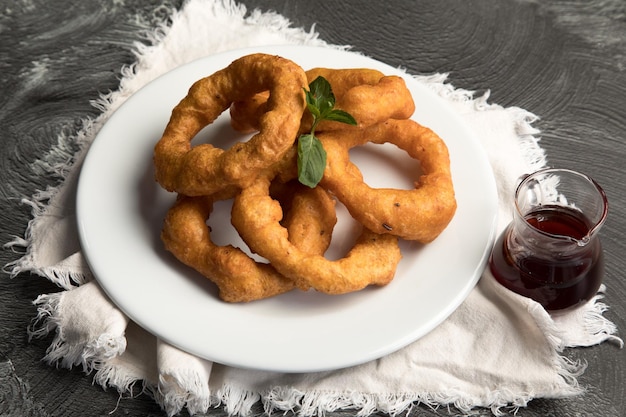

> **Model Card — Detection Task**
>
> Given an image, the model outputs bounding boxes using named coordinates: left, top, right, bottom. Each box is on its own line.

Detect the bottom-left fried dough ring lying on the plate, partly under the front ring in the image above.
left=161, top=184, right=337, bottom=303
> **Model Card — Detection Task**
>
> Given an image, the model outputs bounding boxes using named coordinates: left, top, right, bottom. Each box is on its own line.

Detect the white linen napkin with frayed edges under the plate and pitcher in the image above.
left=6, top=0, right=623, bottom=416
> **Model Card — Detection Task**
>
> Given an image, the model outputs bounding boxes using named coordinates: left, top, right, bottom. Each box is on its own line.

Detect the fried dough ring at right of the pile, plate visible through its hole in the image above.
left=318, top=119, right=456, bottom=243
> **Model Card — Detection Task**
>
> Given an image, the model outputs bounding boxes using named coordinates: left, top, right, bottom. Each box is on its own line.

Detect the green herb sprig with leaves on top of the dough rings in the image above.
left=298, top=76, right=356, bottom=188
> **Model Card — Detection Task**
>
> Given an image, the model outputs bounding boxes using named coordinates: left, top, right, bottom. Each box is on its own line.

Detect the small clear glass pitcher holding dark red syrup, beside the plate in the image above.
left=489, top=168, right=608, bottom=312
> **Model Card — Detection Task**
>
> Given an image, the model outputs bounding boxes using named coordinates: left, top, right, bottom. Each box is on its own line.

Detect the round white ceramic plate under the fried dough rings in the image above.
left=77, top=46, right=497, bottom=372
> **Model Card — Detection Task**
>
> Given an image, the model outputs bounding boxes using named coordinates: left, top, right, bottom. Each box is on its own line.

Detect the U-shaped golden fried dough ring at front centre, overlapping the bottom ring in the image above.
left=231, top=177, right=402, bottom=294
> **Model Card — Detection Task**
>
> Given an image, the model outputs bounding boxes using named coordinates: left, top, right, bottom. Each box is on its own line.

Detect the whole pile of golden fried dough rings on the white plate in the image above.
left=154, top=54, right=456, bottom=302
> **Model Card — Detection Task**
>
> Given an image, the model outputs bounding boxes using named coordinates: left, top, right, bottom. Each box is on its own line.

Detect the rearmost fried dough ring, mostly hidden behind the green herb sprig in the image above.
left=230, top=68, right=415, bottom=133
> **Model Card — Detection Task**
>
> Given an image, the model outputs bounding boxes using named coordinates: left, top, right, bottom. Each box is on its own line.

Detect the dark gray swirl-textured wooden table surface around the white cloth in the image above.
left=0, top=0, right=626, bottom=417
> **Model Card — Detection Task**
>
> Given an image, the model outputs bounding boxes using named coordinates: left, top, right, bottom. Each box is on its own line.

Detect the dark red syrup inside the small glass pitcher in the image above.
left=489, top=206, right=604, bottom=311
